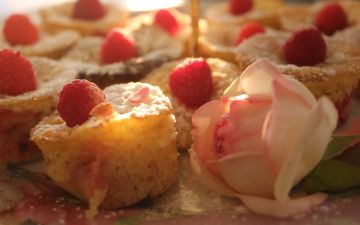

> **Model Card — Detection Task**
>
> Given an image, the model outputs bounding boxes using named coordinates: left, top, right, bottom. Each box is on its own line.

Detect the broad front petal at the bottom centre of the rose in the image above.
left=218, top=149, right=276, bottom=198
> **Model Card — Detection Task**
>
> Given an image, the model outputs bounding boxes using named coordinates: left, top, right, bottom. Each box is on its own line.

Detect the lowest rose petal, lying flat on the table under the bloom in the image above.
left=238, top=193, right=327, bottom=218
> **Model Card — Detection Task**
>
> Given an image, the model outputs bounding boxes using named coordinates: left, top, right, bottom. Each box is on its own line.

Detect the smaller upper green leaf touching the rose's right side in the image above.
left=323, top=135, right=360, bottom=160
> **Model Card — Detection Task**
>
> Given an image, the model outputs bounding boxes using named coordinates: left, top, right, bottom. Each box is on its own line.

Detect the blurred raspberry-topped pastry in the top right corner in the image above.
left=280, top=0, right=360, bottom=35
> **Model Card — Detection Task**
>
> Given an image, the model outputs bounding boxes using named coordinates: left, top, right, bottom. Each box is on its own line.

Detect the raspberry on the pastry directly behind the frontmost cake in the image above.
left=101, top=30, right=136, bottom=63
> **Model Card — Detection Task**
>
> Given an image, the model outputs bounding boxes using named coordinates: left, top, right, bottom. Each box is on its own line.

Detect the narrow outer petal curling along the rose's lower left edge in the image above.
left=189, top=149, right=236, bottom=196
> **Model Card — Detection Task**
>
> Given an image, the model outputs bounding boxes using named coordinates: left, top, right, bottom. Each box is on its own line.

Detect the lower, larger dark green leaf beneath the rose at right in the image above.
left=304, top=159, right=360, bottom=193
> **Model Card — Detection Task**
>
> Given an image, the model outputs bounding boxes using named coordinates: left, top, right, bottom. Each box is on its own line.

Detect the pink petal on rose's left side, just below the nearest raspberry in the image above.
left=192, top=99, right=230, bottom=165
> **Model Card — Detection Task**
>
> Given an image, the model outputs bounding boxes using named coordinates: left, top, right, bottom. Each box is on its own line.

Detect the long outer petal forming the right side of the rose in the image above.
left=274, top=97, right=338, bottom=201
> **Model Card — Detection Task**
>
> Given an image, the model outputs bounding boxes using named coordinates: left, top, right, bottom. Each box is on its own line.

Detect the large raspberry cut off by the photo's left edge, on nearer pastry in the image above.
left=0, top=49, right=37, bottom=95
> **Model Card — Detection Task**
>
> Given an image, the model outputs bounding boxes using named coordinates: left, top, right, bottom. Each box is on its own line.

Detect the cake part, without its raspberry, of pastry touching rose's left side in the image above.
left=142, top=58, right=241, bottom=150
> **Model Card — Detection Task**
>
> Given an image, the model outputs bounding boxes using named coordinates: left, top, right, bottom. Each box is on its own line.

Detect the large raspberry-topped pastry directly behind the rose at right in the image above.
left=236, top=28, right=360, bottom=121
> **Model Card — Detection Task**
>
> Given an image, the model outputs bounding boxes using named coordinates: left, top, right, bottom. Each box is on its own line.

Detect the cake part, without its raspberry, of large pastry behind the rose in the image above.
left=236, top=32, right=360, bottom=119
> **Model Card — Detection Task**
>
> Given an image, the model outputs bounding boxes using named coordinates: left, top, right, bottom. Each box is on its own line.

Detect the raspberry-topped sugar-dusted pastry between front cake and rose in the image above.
left=142, top=58, right=240, bottom=149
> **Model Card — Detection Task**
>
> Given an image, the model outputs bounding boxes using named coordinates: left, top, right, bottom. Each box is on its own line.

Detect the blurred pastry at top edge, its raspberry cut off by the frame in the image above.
left=205, top=0, right=284, bottom=28
